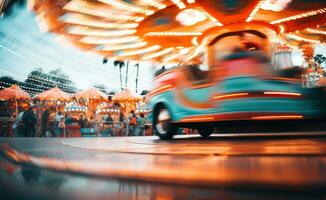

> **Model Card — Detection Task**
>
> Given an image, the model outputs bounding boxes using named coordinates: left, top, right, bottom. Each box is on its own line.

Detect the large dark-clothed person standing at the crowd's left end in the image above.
left=22, top=106, right=37, bottom=137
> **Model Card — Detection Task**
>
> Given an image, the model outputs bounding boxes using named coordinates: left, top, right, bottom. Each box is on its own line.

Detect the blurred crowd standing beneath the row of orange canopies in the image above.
left=7, top=105, right=148, bottom=137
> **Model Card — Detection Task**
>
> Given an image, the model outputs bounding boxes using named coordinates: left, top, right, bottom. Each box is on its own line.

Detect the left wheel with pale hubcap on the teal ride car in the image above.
left=153, top=107, right=177, bottom=140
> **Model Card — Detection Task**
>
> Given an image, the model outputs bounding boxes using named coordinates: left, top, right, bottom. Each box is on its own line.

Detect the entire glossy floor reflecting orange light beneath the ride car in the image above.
left=0, top=132, right=326, bottom=199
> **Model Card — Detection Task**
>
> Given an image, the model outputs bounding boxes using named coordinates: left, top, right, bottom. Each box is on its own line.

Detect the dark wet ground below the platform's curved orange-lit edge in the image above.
left=0, top=157, right=326, bottom=200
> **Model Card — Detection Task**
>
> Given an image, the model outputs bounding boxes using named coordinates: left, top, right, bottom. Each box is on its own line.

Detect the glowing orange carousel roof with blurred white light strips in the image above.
left=30, top=0, right=326, bottom=62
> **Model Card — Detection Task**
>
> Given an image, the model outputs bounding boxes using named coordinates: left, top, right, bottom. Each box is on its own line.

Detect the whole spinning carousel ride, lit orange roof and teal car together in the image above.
left=31, top=0, right=326, bottom=139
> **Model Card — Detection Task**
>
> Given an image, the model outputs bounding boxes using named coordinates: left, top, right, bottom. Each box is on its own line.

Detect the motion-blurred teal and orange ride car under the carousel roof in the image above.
left=149, top=26, right=325, bottom=139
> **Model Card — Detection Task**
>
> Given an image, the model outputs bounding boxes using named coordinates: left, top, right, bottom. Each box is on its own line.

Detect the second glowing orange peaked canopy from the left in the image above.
left=35, top=87, right=71, bottom=101
